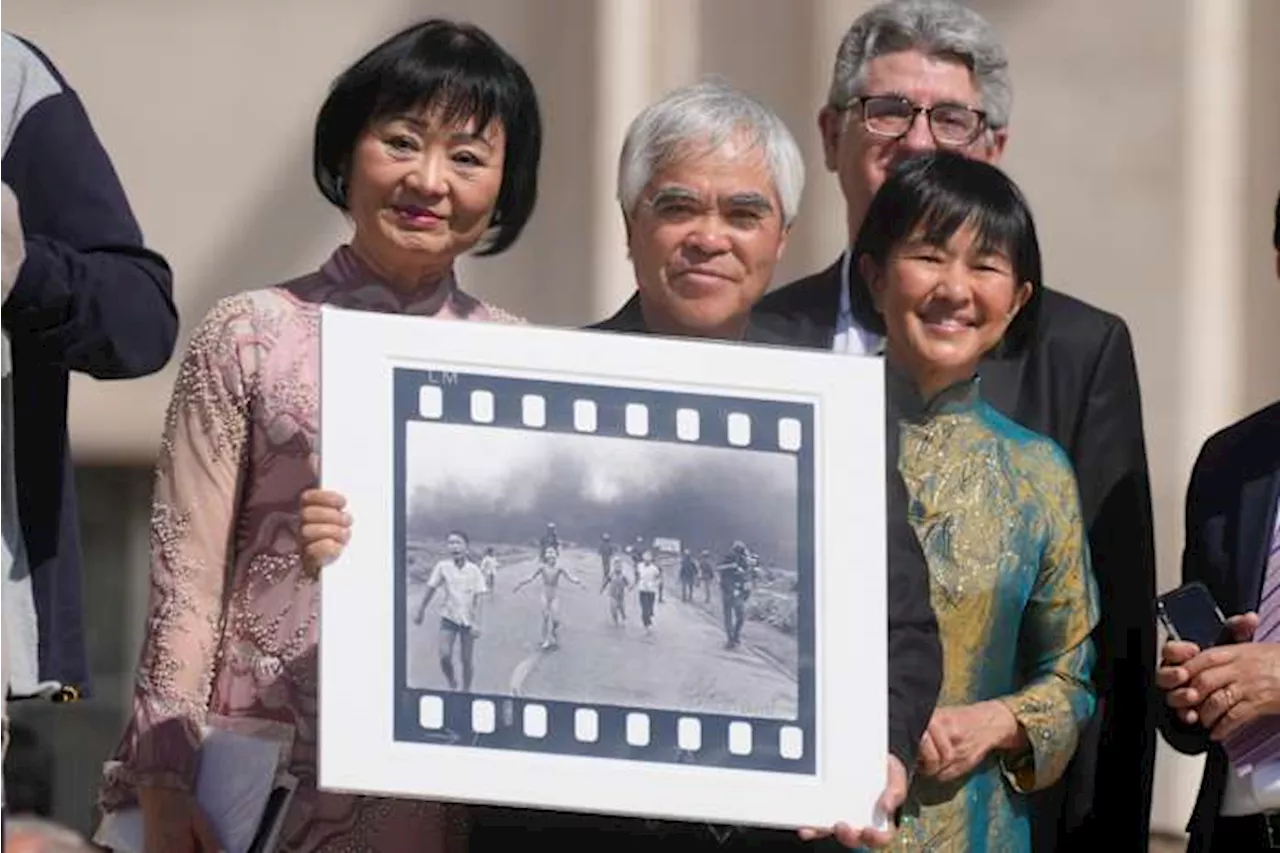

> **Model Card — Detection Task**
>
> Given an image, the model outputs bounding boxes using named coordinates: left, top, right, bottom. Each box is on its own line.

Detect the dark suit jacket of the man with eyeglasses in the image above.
left=756, top=261, right=1157, bottom=853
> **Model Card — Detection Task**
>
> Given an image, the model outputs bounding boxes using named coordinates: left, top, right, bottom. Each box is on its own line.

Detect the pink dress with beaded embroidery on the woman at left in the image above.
left=101, top=247, right=521, bottom=853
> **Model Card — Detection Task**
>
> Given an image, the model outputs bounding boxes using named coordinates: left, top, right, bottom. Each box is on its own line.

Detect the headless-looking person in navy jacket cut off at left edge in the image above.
left=0, top=32, right=178, bottom=701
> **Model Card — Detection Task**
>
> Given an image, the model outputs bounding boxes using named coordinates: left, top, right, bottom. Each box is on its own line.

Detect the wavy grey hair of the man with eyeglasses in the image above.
left=827, top=0, right=1014, bottom=129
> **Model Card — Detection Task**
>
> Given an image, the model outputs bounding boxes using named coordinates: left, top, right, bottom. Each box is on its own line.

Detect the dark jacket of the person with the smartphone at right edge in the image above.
left=1160, top=403, right=1280, bottom=853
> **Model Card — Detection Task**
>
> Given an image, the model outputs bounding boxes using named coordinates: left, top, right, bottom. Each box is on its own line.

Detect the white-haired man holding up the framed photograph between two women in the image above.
left=301, top=76, right=942, bottom=853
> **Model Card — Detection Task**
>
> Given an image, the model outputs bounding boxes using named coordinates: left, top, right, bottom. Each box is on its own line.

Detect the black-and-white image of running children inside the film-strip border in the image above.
left=402, top=420, right=801, bottom=720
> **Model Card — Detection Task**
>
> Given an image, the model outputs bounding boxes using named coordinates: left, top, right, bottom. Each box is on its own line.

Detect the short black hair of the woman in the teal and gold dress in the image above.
left=854, top=151, right=1042, bottom=343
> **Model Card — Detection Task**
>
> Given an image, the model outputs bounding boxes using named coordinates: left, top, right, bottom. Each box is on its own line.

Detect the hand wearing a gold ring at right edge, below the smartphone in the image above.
left=1183, top=643, right=1280, bottom=740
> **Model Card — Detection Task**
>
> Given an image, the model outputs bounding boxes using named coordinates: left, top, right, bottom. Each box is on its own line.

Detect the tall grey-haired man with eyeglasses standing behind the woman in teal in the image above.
left=756, top=0, right=1157, bottom=853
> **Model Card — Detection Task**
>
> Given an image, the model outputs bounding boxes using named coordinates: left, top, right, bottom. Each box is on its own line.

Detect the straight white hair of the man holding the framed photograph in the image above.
left=618, top=81, right=804, bottom=225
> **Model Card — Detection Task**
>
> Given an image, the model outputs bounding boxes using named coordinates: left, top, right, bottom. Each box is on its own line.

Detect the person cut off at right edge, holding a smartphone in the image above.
left=1156, top=190, right=1280, bottom=853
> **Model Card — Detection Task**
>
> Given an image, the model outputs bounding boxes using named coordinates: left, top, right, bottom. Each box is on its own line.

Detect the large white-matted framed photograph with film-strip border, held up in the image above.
left=319, top=307, right=887, bottom=827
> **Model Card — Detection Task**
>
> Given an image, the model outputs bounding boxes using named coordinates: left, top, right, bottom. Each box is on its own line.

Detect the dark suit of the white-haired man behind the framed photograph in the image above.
left=470, top=297, right=942, bottom=853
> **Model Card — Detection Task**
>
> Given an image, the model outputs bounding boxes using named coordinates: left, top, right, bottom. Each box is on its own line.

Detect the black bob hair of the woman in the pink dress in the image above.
left=320, top=18, right=543, bottom=255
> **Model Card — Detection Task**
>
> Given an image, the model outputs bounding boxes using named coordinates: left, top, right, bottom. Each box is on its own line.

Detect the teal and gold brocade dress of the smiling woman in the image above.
left=890, top=377, right=1098, bottom=853
